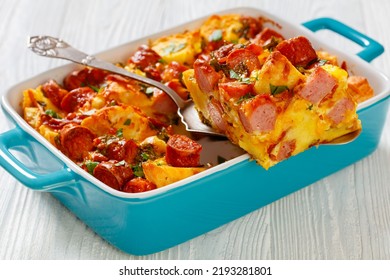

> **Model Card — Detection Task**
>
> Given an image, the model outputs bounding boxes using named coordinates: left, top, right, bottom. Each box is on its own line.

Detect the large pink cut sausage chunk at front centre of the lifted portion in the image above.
left=238, top=95, right=277, bottom=133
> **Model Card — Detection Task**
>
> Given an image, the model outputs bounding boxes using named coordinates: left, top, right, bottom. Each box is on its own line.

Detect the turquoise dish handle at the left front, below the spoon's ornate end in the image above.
left=0, top=127, right=74, bottom=191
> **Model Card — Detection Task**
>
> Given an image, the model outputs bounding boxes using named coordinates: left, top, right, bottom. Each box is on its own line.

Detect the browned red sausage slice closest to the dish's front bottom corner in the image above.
left=93, top=160, right=134, bottom=190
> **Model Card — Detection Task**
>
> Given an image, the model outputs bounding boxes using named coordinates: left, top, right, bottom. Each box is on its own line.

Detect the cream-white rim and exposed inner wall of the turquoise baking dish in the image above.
left=2, top=8, right=390, bottom=198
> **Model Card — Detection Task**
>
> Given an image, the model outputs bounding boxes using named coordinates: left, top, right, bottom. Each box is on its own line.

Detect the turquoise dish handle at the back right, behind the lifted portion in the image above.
left=302, top=17, right=384, bottom=62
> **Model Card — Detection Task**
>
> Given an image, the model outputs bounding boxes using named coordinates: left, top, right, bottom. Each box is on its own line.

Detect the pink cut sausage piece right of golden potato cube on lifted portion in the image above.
left=298, top=67, right=337, bottom=104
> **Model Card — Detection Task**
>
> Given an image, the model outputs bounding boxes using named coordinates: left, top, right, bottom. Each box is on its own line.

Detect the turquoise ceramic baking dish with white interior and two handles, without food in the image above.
left=0, top=8, right=390, bottom=255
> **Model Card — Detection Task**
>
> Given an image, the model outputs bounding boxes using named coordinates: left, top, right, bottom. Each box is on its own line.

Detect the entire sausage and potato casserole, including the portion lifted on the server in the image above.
left=22, top=15, right=372, bottom=192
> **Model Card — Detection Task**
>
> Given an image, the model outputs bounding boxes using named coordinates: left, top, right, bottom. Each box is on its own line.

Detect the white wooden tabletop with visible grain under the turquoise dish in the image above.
left=0, top=0, right=390, bottom=259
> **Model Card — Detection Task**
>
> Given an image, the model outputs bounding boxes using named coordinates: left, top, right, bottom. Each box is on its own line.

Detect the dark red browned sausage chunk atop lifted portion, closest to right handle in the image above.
left=275, top=36, right=317, bottom=67
